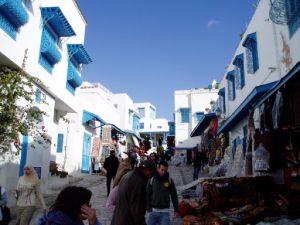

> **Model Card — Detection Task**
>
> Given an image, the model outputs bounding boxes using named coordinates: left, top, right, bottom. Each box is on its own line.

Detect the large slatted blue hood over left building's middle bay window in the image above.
left=41, top=7, right=76, bottom=37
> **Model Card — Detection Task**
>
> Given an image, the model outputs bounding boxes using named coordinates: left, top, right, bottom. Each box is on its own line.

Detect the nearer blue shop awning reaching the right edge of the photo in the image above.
left=255, top=62, right=300, bottom=108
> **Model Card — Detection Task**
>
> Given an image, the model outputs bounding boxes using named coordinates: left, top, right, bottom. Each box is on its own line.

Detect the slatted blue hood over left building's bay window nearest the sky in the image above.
left=68, top=44, right=92, bottom=64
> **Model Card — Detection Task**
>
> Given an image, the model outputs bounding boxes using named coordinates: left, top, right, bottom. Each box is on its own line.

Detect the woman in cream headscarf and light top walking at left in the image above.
left=16, top=165, right=46, bottom=225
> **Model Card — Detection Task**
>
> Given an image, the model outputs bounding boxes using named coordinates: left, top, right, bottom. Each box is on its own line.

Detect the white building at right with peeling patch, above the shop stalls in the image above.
left=213, top=0, right=300, bottom=179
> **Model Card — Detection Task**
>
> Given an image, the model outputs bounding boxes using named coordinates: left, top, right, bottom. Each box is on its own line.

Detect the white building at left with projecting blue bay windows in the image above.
left=0, top=0, right=91, bottom=200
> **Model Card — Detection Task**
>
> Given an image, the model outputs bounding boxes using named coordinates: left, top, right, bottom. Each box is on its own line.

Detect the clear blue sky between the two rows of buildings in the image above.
left=78, top=0, right=257, bottom=120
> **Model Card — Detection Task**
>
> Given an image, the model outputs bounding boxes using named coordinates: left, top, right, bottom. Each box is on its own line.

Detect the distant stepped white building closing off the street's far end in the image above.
left=134, top=102, right=169, bottom=149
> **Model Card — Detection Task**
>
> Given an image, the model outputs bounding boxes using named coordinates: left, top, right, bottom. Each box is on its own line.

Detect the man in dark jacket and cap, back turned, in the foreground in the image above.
left=111, top=160, right=156, bottom=225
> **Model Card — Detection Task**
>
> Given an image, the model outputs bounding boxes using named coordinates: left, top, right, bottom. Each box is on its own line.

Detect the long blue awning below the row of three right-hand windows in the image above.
left=217, top=82, right=276, bottom=135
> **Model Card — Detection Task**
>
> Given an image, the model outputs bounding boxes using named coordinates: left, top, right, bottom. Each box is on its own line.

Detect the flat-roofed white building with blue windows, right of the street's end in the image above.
left=174, top=88, right=219, bottom=162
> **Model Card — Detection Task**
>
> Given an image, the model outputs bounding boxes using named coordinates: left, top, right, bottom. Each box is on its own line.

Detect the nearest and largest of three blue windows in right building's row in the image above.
left=243, top=33, right=259, bottom=74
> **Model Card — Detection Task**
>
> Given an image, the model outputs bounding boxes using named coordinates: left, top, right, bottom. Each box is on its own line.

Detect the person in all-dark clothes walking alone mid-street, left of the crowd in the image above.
left=103, top=151, right=119, bottom=196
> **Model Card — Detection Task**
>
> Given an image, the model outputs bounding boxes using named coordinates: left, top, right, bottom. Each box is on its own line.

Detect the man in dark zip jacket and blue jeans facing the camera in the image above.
left=147, top=161, right=178, bottom=225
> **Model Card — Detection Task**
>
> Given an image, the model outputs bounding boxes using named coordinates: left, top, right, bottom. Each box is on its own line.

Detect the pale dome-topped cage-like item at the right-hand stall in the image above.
left=254, top=144, right=270, bottom=172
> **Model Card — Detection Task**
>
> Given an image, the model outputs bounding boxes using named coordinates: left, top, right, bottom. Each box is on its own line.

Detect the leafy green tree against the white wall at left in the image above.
left=0, top=49, right=50, bottom=157
